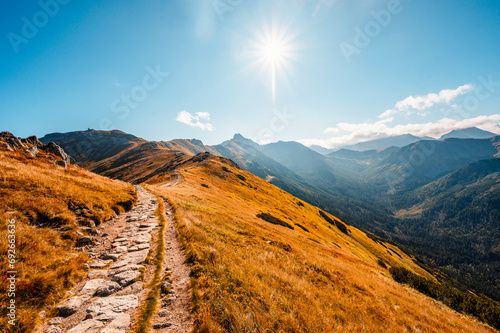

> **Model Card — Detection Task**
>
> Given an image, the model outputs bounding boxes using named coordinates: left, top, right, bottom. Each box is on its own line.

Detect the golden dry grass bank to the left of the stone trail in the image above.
left=0, top=150, right=136, bottom=332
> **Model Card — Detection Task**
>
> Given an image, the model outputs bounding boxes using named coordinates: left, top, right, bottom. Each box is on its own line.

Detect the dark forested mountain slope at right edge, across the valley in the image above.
left=396, top=158, right=500, bottom=299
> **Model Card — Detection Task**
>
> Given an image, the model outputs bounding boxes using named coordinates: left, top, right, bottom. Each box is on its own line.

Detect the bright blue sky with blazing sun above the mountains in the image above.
left=0, top=0, right=500, bottom=147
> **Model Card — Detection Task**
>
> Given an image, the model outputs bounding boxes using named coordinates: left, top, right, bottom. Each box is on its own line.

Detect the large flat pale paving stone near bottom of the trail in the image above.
left=87, top=295, right=139, bottom=320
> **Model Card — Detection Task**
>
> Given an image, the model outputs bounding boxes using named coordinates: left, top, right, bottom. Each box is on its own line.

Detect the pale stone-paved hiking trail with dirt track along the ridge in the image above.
left=35, top=186, right=193, bottom=333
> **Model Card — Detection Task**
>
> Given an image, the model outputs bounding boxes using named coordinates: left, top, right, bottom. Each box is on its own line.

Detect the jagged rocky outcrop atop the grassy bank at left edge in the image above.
left=0, top=132, right=75, bottom=167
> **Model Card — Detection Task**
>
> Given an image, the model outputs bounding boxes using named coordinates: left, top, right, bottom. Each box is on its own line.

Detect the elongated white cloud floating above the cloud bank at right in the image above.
left=379, top=84, right=474, bottom=118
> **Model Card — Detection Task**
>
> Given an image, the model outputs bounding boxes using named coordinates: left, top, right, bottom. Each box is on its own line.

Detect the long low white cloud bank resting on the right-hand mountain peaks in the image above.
left=299, top=114, right=500, bottom=148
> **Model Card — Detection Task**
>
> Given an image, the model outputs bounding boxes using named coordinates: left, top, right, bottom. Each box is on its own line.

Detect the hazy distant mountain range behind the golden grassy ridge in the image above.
left=41, top=130, right=500, bottom=299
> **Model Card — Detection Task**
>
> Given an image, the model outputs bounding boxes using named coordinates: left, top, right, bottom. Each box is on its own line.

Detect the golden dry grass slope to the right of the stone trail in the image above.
left=151, top=157, right=495, bottom=332
